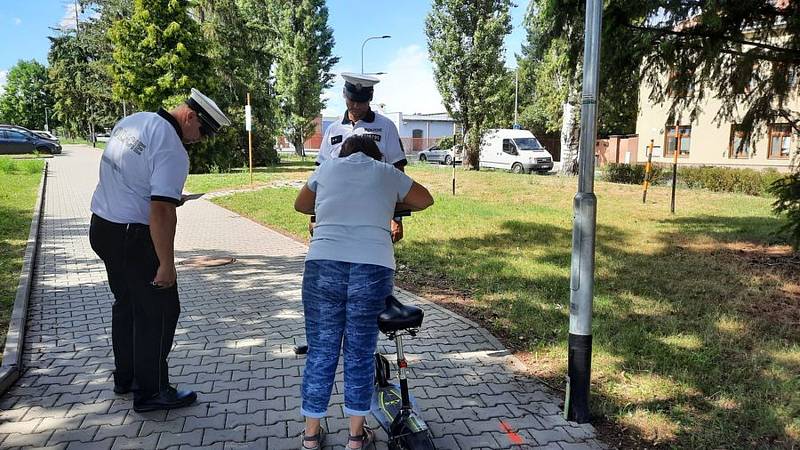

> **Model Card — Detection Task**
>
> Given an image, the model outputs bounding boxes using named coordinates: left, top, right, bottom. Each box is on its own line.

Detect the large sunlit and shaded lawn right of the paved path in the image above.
left=189, top=165, right=800, bottom=448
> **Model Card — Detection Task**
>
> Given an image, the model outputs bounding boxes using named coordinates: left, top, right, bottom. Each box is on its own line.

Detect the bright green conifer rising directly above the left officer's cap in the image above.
left=109, top=0, right=210, bottom=110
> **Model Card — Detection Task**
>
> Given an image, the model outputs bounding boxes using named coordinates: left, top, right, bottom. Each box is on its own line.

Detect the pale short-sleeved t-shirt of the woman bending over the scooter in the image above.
left=306, top=152, right=413, bottom=269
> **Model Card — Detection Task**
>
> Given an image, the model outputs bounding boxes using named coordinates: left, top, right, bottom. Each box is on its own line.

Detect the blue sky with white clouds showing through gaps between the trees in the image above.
left=0, top=0, right=527, bottom=115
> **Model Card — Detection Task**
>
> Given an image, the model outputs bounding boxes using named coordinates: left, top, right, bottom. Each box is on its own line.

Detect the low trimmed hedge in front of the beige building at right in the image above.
left=604, top=164, right=782, bottom=195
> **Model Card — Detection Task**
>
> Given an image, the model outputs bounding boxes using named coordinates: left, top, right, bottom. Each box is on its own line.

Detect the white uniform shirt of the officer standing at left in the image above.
left=91, top=110, right=189, bottom=225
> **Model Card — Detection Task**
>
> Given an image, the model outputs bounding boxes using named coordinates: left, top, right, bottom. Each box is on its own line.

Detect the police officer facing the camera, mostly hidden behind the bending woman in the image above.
left=316, top=72, right=408, bottom=242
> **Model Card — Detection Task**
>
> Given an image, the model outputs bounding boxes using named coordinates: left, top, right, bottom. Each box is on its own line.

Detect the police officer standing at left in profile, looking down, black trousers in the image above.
left=89, top=89, right=230, bottom=412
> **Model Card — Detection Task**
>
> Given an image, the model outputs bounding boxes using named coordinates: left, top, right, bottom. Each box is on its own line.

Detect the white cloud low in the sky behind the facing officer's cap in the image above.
left=323, top=45, right=445, bottom=116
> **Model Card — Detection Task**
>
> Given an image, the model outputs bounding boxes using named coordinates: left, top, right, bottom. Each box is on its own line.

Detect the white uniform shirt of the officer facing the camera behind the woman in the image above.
left=317, top=110, right=408, bottom=165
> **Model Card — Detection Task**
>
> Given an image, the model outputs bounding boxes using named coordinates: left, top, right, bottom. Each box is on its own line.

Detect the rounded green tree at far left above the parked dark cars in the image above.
left=0, top=59, right=53, bottom=130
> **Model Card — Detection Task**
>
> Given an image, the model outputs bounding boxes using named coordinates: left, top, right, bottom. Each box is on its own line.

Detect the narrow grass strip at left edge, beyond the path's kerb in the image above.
left=0, top=157, right=44, bottom=357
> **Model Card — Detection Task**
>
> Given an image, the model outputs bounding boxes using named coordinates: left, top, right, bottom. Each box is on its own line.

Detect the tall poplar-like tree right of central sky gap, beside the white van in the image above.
left=425, top=0, right=513, bottom=169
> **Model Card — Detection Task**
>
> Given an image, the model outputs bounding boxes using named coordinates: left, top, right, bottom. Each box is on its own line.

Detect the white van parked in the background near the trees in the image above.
left=480, top=129, right=553, bottom=173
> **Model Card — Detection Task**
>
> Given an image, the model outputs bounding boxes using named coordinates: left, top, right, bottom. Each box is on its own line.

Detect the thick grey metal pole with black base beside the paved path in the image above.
left=564, top=0, right=603, bottom=423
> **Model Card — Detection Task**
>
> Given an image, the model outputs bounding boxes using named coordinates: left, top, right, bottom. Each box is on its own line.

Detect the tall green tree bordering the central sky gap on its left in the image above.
left=273, top=0, right=339, bottom=155
